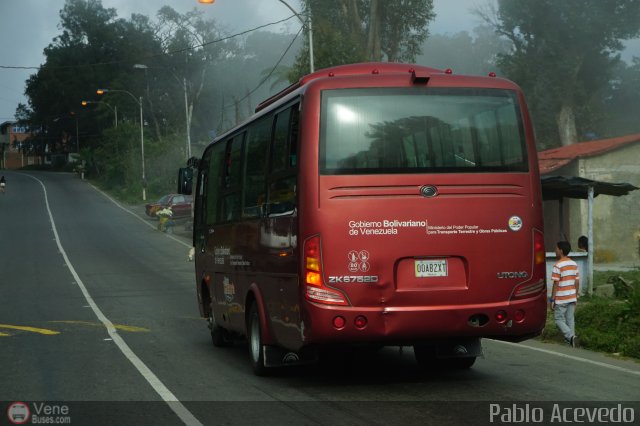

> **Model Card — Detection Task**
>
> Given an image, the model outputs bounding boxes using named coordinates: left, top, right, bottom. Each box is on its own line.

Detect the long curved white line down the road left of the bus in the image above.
left=26, top=175, right=202, bottom=426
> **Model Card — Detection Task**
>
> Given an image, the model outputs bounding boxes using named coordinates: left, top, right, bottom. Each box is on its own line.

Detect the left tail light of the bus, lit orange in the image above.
left=304, top=235, right=348, bottom=306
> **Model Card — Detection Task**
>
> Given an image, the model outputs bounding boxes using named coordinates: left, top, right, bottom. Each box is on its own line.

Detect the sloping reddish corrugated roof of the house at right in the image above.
left=538, top=133, right=640, bottom=175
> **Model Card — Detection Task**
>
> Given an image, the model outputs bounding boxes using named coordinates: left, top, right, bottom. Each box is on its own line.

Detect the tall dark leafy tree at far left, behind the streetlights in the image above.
left=21, top=0, right=159, bottom=153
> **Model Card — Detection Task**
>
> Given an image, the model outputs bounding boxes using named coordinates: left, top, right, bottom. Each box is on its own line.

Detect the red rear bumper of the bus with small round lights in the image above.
left=304, top=293, right=546, bottom=345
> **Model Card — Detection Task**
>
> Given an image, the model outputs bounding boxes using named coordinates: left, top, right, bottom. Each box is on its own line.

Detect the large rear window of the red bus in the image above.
left=320, top=88, right=528, bottom=174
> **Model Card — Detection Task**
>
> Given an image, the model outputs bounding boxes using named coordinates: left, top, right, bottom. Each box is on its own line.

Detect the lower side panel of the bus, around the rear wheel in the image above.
left=200, top=217, right=301, bottom=347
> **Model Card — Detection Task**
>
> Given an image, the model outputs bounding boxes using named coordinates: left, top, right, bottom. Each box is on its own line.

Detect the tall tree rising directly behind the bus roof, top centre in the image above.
left=289, top=0, right=435, bottom=82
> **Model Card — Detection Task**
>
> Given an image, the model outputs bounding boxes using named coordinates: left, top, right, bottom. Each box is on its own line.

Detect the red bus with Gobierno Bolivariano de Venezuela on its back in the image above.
left=180, top=63, right=546, bottom=374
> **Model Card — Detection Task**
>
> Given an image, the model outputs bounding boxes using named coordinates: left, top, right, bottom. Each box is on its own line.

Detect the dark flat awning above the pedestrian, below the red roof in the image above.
left=541, top=176, right=640, bottom=200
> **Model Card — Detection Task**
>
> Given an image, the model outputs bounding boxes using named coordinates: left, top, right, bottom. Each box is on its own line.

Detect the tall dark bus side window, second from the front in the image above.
left=221, top=133, right=244, bottom=222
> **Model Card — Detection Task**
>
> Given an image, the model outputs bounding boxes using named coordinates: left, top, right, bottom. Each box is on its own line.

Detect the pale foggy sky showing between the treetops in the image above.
left=0, top=0, right=640, bottom=123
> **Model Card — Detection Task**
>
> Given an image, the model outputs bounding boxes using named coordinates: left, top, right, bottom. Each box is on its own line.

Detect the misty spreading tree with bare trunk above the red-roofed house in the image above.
left=478, top=0, right=640, bottom=146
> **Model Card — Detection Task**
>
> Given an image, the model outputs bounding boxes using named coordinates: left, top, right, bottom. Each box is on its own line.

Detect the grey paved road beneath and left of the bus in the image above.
left=0, top=171, right=640, bottom=425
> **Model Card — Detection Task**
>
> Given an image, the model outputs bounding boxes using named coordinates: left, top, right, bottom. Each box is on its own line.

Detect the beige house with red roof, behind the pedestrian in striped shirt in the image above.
left=538, top=134, right=640, bottom=263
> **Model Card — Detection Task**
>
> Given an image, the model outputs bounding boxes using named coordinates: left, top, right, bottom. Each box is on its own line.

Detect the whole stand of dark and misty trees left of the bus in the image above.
left=17, top=0, right=296, bottom=196
